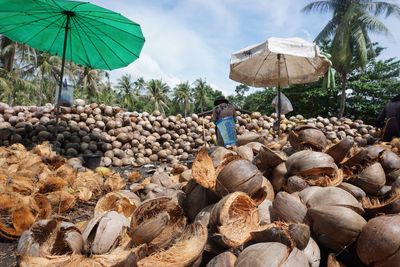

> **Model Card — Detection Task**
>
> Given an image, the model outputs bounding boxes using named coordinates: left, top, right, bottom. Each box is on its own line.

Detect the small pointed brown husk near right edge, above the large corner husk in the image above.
left=355, top=162, right=386, bottom=194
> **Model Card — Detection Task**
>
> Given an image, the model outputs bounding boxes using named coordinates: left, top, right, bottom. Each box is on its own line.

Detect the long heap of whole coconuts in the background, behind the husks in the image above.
left=0, top=100, right=379, bottom=167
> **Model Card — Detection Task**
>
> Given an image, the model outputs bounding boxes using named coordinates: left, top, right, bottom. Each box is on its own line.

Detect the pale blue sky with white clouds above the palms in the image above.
left=90, top=0, right=400, bottom=95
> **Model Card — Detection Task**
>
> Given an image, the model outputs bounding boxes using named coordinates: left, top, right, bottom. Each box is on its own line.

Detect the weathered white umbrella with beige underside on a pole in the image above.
left=229, top=37, right=331, bottom=134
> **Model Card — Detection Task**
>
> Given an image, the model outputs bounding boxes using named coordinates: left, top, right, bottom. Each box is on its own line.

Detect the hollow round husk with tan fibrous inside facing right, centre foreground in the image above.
left=210, top=192, right=259, bottom=248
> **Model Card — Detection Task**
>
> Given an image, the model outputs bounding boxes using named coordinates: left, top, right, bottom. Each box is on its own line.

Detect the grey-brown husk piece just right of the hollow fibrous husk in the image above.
left=271, top=192, right=307, bottom=223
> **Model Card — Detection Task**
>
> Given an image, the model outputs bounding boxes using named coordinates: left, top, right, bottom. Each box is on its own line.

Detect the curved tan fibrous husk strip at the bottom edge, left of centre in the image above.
left=138, top=223, right=208, bottom=267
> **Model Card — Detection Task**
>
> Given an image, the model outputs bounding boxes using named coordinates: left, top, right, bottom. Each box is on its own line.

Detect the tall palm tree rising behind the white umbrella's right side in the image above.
left=303, top=0, right=400, bottom=117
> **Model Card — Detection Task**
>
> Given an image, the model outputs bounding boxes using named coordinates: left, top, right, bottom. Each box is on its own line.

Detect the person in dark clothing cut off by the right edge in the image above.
left=376, top=94, right=400, bottom=142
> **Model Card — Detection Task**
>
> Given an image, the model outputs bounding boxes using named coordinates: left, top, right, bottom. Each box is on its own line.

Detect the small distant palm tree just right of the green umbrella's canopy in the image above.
left=146, top=79, right=169, bottom=114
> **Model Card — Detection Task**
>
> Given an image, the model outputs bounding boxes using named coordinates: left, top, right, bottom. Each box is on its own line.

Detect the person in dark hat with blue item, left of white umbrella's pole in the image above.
left=212, top=96, right=236, bottom=146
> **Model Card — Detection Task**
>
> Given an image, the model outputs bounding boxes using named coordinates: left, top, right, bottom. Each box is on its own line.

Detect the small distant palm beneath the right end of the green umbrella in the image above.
left=116, top=74, right=138, bottom=111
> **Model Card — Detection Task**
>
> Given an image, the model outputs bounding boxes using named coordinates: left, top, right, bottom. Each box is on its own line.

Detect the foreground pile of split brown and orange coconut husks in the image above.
left=0, top=127, right=400, bottom=267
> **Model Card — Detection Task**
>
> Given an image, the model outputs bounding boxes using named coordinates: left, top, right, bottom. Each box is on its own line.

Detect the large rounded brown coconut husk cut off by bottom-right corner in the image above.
left=357, top=215, right=400, bottom=266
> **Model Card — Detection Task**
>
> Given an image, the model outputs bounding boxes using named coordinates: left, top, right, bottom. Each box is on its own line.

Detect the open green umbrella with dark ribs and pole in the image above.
left=0, top=0, right=144, bottom=126
